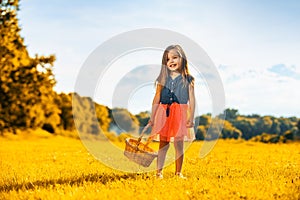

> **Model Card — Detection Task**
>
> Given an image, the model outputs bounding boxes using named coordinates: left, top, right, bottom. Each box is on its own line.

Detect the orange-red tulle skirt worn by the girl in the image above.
left=151, top=103, right=193, bottom=141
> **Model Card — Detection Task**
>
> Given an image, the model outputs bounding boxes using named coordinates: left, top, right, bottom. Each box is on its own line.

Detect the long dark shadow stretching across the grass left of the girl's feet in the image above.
left=0, top=174, right=148, bottom=192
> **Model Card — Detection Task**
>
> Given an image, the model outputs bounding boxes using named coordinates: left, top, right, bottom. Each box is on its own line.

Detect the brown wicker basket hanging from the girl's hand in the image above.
left=124, top=125, right=157, bottom=167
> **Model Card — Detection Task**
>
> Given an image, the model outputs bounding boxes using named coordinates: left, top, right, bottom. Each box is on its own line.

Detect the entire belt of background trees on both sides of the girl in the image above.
left=0, top=0, right=300, bottom=143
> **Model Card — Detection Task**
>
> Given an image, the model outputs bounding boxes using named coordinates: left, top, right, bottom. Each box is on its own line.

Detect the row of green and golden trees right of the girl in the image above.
left=196, top=108, right=300, bottom=143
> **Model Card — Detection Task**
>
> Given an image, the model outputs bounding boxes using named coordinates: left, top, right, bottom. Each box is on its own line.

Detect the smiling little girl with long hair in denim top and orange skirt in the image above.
left=148, top=45, right=195, bottom=178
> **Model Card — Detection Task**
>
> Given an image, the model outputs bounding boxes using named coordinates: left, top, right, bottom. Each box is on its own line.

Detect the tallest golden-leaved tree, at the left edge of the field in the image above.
left=0, top=0, right=60, bottom=132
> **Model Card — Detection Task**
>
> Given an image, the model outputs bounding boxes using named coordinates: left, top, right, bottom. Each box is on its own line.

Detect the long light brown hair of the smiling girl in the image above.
left=156, top=45, right=194, bottom=89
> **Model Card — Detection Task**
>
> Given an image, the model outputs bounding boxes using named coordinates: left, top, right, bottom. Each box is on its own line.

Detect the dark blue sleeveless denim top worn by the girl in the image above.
left=160, top=75, right=193, bottom=104
